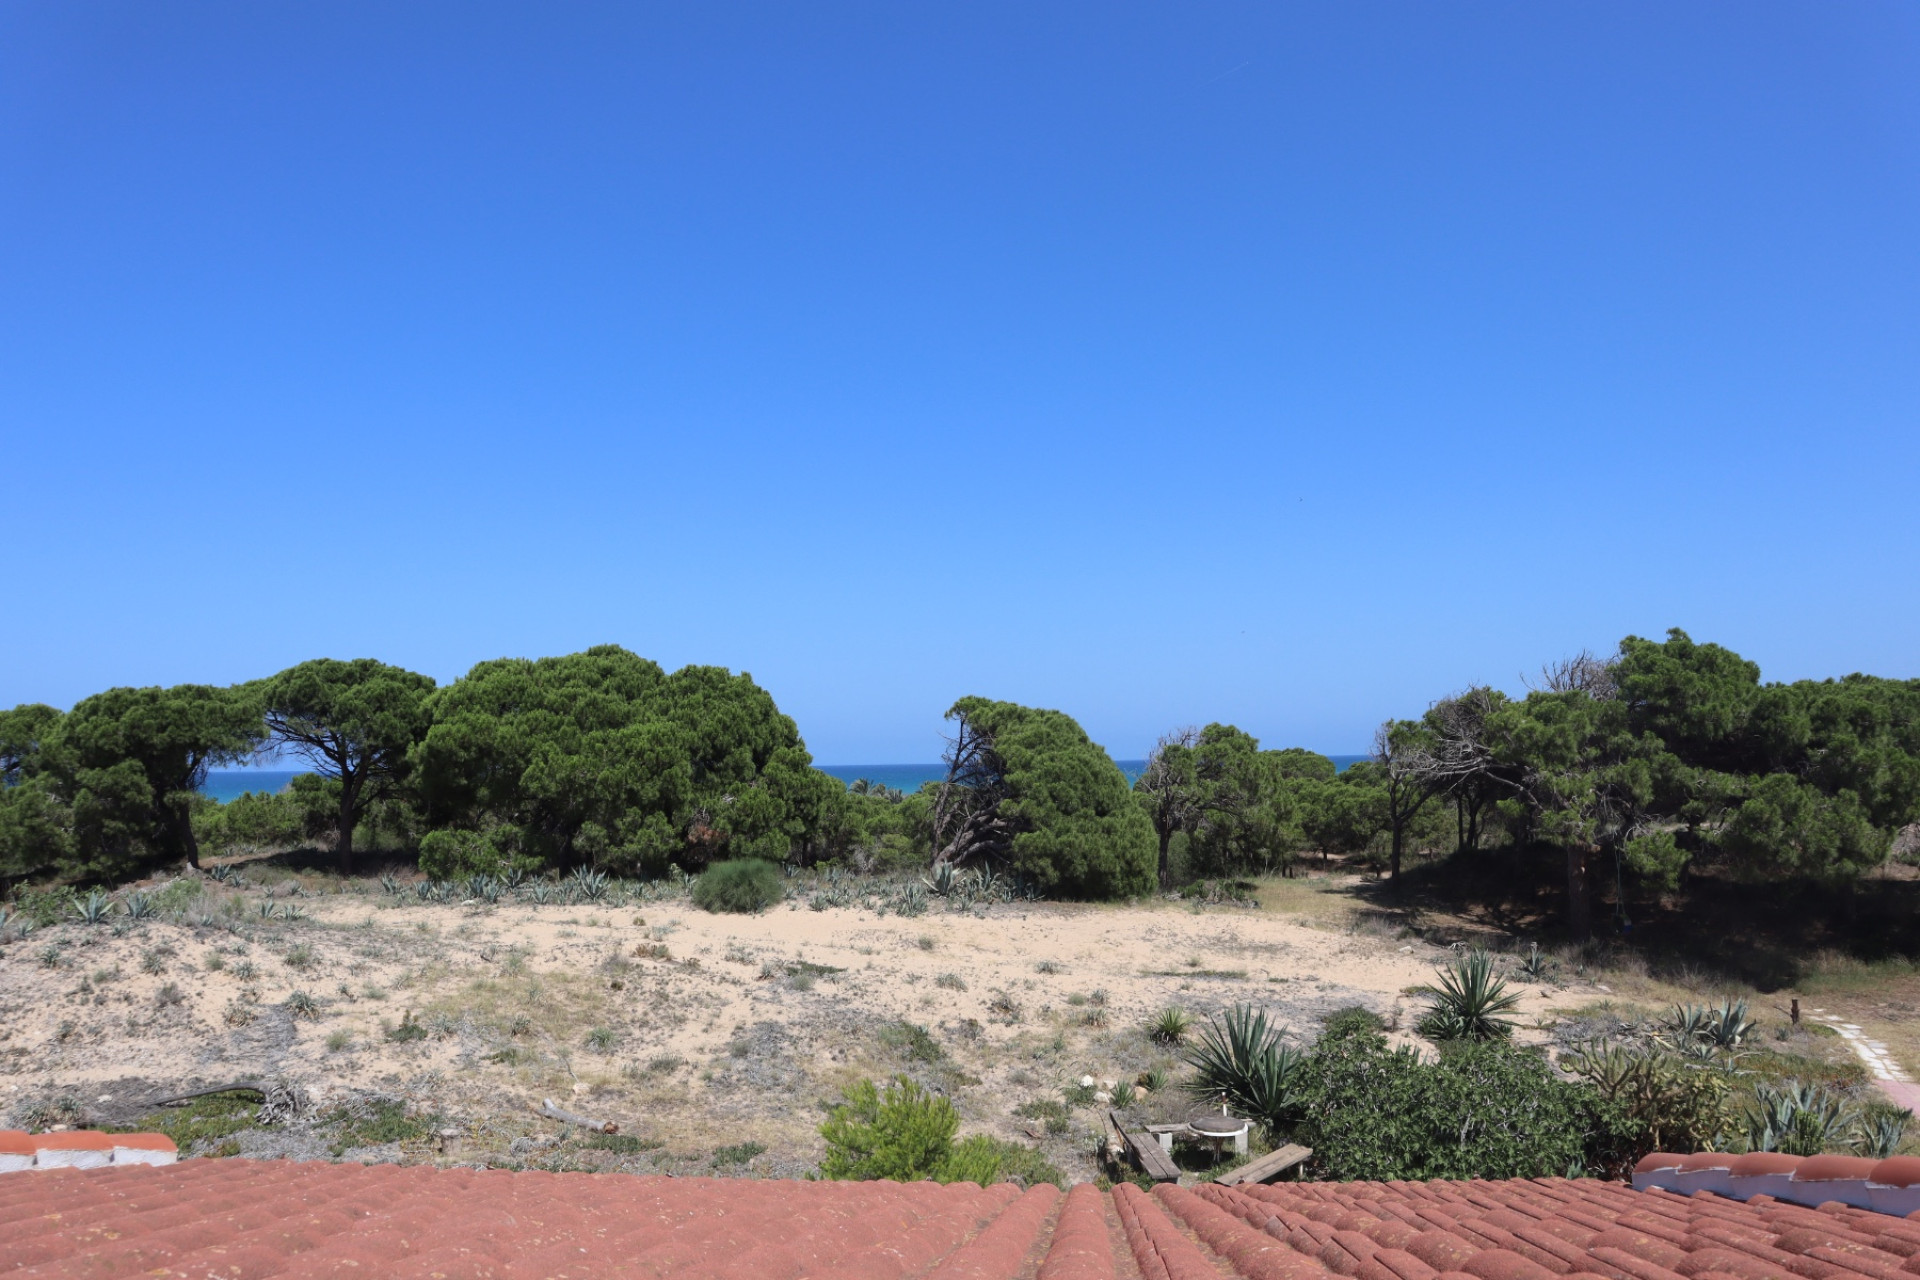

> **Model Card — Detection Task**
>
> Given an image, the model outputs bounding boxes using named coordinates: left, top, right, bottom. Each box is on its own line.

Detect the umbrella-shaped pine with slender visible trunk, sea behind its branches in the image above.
left=253, top=658, right=434, bottom=873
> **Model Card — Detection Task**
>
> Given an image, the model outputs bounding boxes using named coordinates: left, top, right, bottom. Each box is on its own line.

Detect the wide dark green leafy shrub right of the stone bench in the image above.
left=1294, top=1031, right=1634, bottom=1180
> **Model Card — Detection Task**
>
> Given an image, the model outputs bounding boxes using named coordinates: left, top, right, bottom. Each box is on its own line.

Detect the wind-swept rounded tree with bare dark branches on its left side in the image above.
left=933, top=699, right=1154, bottom=900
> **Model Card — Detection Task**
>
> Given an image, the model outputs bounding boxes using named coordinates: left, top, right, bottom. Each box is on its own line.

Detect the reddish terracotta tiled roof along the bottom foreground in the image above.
left=11, top=1136, right=1920, bottom=1280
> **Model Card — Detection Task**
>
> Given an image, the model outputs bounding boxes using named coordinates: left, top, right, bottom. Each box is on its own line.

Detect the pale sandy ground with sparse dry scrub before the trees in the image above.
left=0, top=883, right=1586, bottom=1176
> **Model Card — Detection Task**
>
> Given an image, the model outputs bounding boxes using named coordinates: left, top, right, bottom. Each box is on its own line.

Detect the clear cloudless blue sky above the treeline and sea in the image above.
left=0, top=0, right=1920, bottom=764
